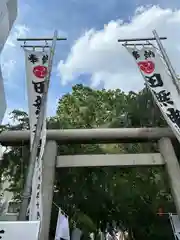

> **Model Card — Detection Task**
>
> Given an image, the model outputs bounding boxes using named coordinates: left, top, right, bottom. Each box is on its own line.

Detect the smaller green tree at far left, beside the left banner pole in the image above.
left=1, top=110, right=29, bottom=199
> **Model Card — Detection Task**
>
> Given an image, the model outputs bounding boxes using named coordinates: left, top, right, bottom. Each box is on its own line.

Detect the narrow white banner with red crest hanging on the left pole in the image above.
left=25, top=49, right=49, bottom=221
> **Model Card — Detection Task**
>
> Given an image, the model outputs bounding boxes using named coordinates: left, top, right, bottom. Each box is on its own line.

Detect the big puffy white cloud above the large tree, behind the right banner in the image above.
left=58, top=6, right=180, bottom=91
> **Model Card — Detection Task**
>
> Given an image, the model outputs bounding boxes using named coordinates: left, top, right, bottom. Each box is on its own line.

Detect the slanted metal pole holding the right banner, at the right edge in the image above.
left=153, top=30, right=180, bottom=94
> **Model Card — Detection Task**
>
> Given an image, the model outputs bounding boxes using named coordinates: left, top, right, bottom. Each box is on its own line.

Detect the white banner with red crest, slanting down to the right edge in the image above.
left=126, top=46, right=180, bottom=142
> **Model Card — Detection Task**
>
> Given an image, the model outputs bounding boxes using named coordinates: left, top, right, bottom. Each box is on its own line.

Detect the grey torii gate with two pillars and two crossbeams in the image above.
left=0, top=128, right=180, bottom=240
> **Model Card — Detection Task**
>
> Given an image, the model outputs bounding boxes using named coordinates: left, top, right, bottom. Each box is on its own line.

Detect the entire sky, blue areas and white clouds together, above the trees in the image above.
left=1, top=0, right=180, bottom=123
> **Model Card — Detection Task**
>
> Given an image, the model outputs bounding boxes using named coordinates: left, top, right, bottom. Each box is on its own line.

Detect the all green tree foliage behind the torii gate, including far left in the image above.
left=2, top=84, right=174, bottom=240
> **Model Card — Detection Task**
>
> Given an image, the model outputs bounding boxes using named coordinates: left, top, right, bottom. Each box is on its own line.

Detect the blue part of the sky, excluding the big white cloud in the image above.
left=1, top=0, right=180, bottom=121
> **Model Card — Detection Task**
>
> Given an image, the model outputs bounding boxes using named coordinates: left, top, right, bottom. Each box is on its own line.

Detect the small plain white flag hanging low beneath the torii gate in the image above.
left=55, top=209, right=70, bottom=240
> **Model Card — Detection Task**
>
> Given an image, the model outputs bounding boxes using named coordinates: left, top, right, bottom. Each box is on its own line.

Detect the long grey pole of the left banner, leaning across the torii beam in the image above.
left=19, top=31, right=58, bottom=221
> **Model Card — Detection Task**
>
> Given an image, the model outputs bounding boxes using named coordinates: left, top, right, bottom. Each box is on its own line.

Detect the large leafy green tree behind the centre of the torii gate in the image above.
left=52, top=85, right=173, bottom=239
